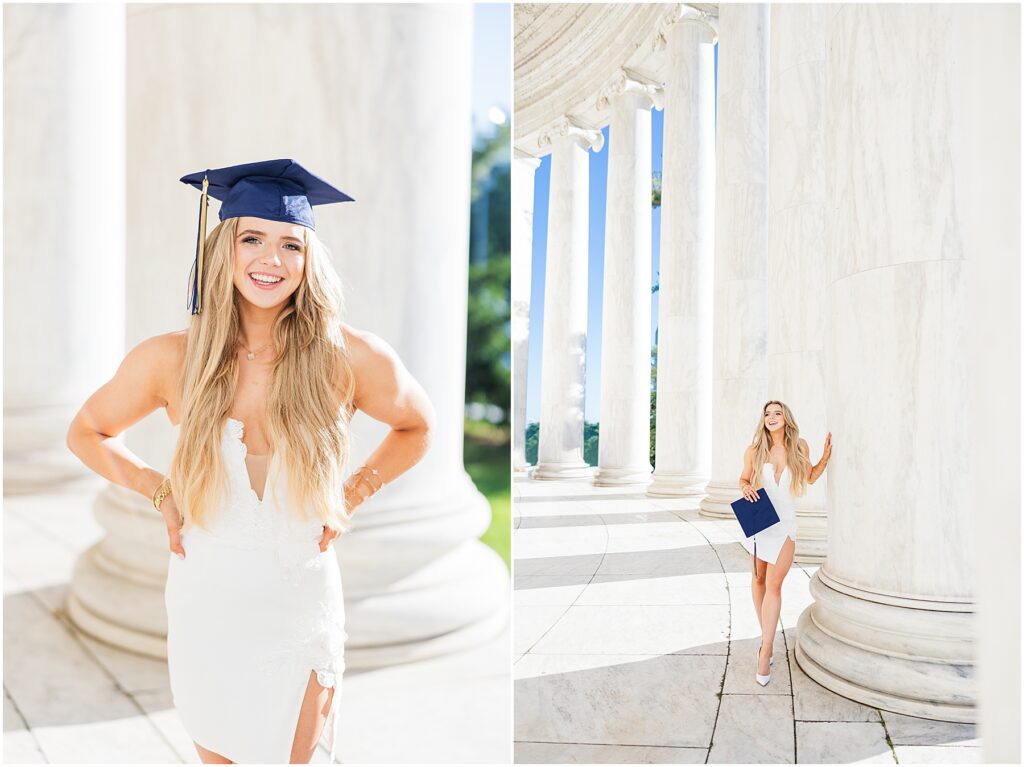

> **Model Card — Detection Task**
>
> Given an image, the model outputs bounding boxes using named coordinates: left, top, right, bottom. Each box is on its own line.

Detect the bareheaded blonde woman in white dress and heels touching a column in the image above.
left=739, top=399, right=831, bottom=686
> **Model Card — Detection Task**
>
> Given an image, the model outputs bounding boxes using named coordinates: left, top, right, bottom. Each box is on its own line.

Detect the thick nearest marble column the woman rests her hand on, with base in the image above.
left=797, top=5, right=978, bottom=722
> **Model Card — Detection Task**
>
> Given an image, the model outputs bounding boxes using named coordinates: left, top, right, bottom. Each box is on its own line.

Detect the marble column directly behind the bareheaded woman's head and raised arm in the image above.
left=768, top=3, right=828, bottom=563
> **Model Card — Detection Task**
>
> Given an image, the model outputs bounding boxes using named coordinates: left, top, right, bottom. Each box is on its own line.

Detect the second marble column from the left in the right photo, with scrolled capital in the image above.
left=531, top=118, right=604, bottom=479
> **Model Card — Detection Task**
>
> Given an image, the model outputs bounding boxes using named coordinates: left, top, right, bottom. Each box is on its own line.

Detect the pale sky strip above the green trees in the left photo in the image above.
left=472, top=3, right=512, bottom=135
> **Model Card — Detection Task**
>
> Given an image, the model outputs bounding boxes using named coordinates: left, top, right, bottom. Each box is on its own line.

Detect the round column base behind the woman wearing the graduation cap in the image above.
left=73, top=475, right=509, bottom=669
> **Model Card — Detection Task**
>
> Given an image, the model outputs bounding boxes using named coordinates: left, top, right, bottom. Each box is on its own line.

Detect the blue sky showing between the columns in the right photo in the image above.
left=526, top=45, right=718, bottom=423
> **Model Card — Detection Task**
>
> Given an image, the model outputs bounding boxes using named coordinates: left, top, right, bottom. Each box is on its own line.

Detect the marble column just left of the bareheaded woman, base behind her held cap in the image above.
left=700, top=3, right=770, bottom=519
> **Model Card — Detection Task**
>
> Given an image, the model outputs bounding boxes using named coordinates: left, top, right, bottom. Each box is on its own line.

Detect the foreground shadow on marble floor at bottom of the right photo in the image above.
left=514, top=630, right=978, bottom=764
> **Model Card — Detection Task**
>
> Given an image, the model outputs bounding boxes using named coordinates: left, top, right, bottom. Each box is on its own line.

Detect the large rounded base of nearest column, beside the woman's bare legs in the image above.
left=797, top=563, right=977, bottom=723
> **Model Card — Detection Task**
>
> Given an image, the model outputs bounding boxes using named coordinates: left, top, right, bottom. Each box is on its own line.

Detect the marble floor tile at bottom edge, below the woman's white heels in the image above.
left=708, top=695, right=796, bottom=764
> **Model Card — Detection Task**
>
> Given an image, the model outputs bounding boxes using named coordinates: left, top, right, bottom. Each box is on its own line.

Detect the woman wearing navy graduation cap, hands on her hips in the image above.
left=68, top=160, right=433, bottom=764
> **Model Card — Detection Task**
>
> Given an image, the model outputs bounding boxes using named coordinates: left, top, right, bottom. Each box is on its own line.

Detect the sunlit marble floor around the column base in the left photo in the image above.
left=3, top=481, right=512, bottom=764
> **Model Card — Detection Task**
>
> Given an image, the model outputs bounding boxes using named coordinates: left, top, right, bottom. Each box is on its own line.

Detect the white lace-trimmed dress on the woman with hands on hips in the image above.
left=164, top=418, right=347, bottom=764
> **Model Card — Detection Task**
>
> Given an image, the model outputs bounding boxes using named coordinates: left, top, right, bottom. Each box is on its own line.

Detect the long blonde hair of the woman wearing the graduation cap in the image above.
left=170, top=218, right=355, bottom=531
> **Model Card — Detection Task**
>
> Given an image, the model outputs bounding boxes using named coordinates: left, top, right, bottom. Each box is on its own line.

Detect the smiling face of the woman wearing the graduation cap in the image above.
left=233, top=216, right=306, bottom=308
